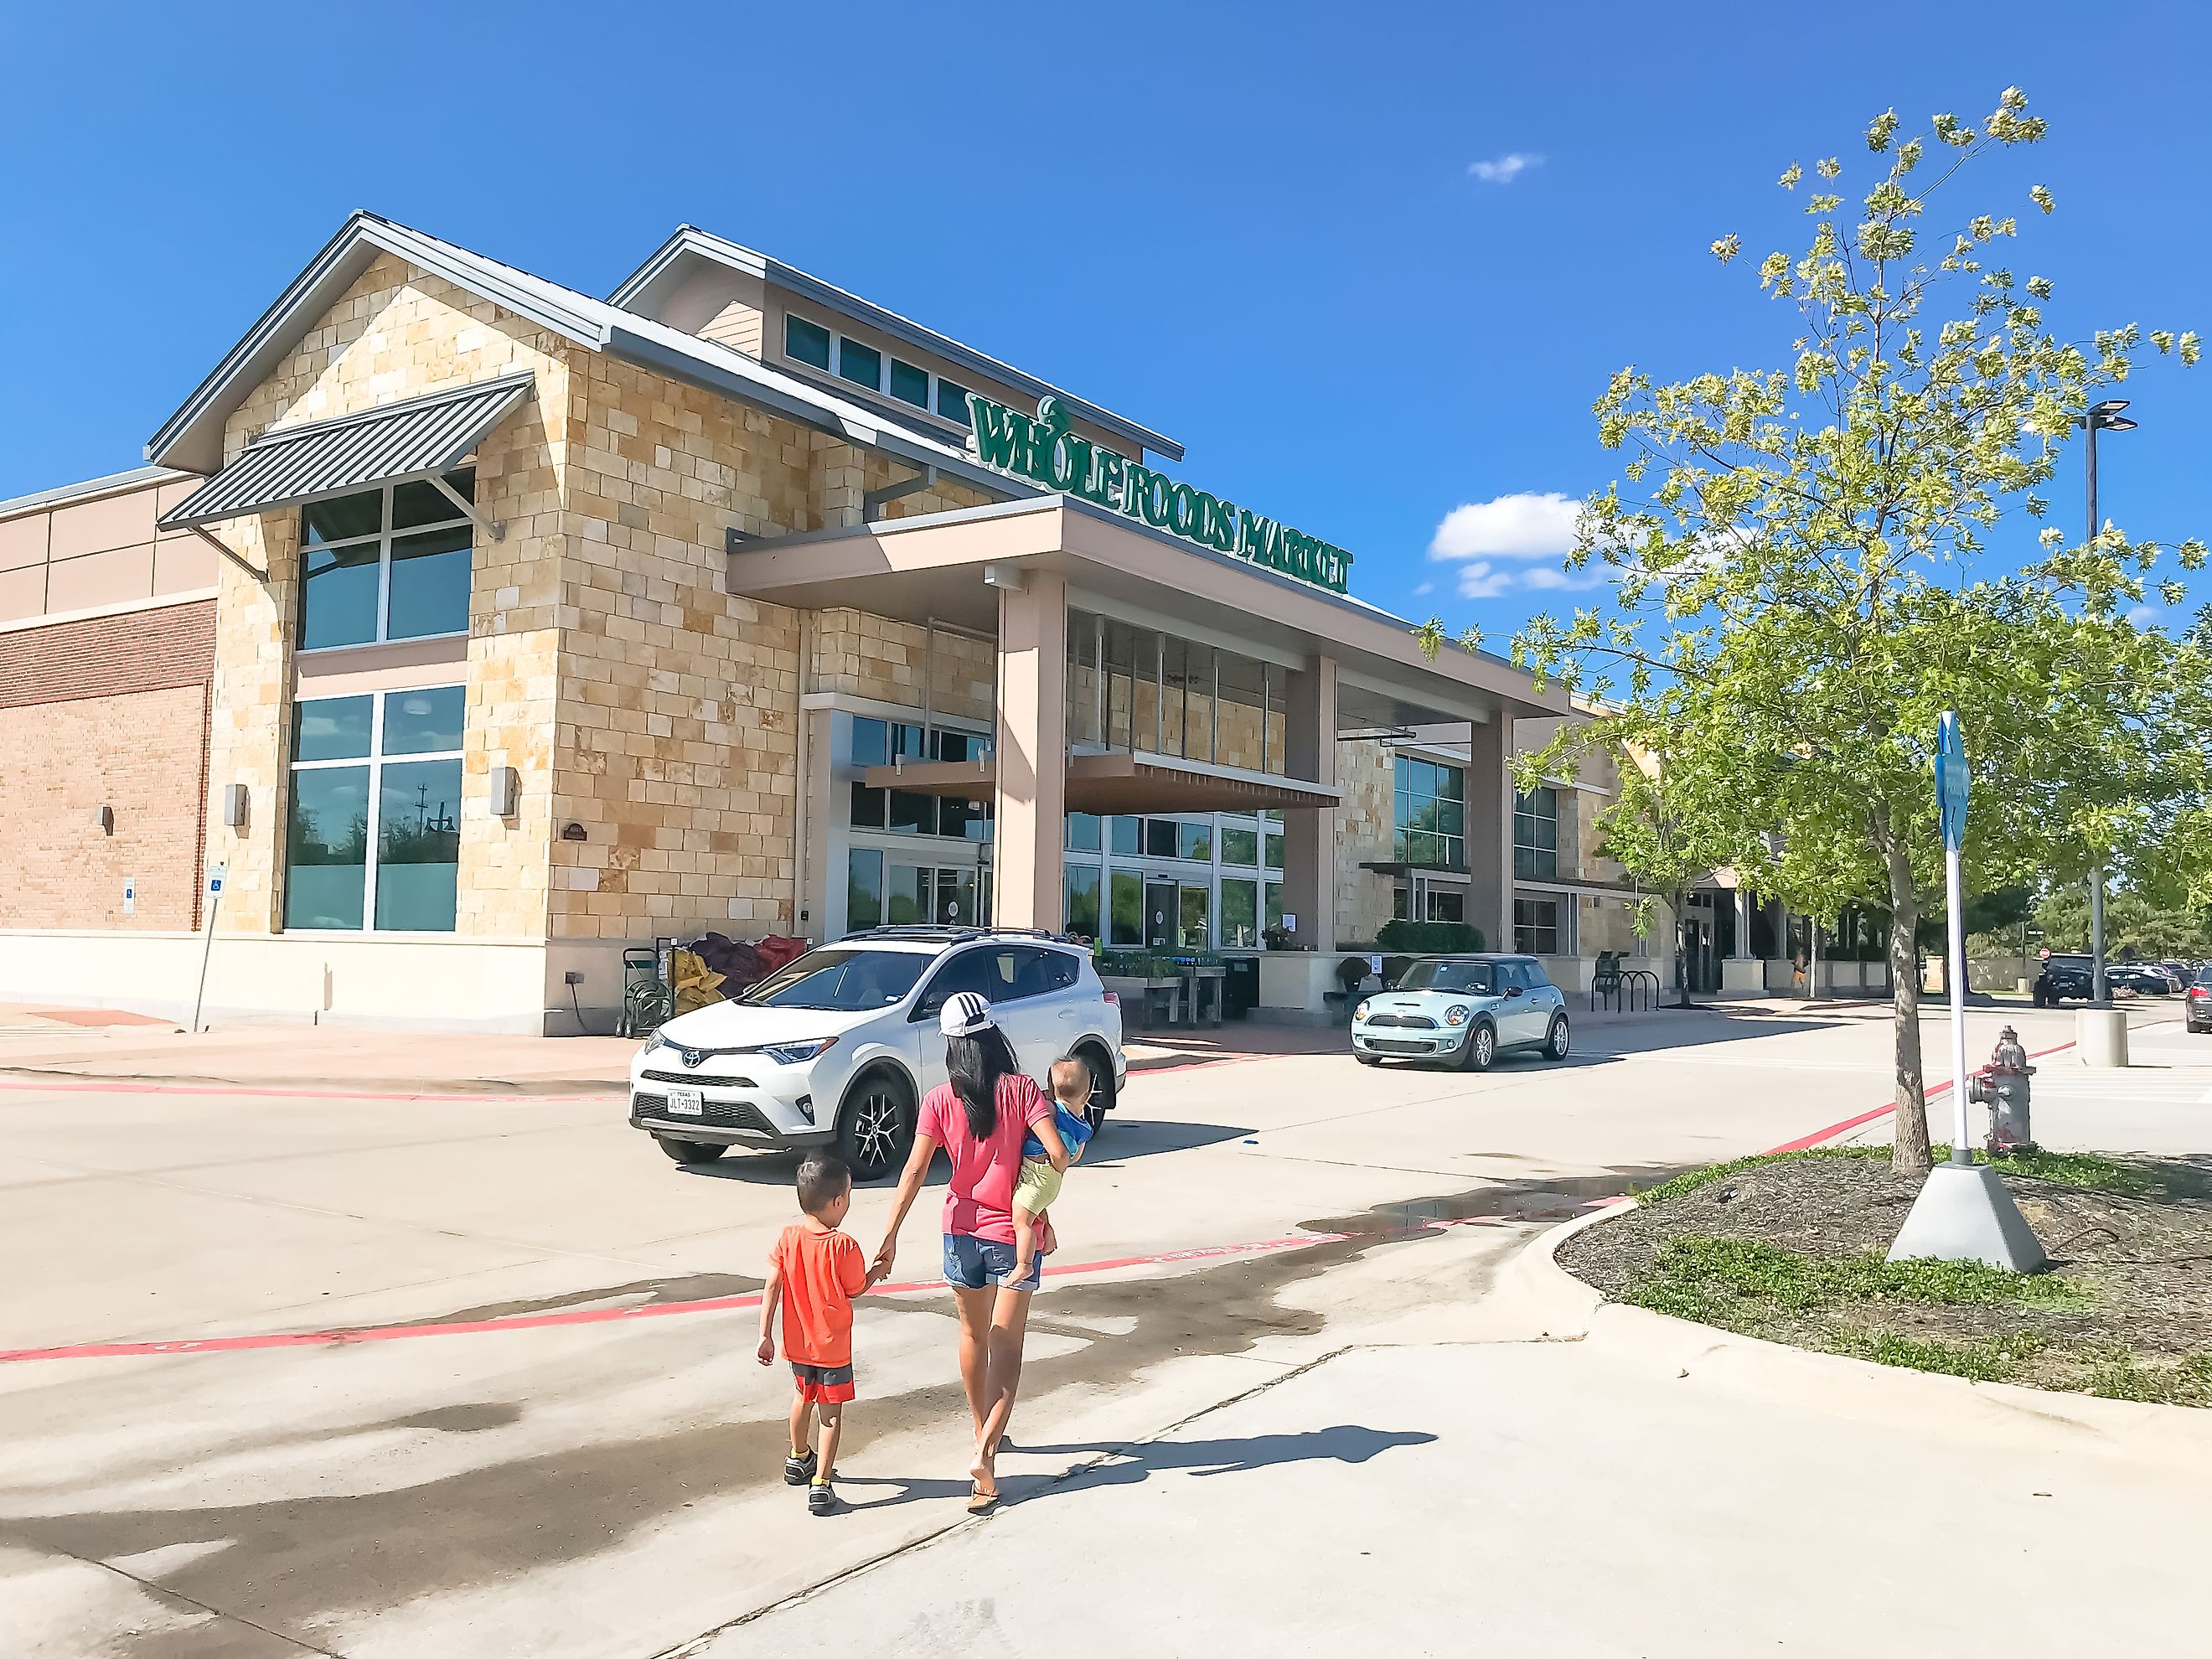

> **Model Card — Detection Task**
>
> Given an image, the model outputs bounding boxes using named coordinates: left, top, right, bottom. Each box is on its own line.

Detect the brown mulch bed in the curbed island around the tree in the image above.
left=1559, top=1148, right=2212, bottom=1404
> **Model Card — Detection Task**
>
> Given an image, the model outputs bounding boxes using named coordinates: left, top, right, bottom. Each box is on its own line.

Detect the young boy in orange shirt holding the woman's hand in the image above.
left=761, top=1152, right=870, bottom=1515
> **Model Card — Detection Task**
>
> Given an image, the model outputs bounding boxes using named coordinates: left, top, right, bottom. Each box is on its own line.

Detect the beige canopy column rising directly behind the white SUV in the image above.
left=991, top=571, right=1068, bottom=933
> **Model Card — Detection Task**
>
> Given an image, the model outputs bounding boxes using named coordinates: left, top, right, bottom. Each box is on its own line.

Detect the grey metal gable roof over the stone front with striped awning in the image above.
left=146, top=212, right=1040, bottom=500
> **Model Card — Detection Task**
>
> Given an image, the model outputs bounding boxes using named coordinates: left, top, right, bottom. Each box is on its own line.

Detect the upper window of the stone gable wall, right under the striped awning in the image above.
left=298, top=471, right=476, bottom=650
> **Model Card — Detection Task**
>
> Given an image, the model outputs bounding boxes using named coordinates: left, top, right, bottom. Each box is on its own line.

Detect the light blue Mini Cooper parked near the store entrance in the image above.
left=1351, top=955, right=1566, bottom=1071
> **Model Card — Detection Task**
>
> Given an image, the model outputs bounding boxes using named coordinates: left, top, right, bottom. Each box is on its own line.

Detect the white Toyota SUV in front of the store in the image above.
left=630, top=927, right=1128, bottom=1181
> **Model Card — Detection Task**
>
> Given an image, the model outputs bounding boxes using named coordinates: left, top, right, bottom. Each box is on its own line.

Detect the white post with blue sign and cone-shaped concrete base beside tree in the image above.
left=1889, top=715, right=2049, bottom=1274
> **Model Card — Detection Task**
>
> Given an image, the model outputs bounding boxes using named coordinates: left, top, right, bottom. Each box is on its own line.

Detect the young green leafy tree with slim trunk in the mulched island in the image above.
left=1427, top=89, right=2205, bottom=1171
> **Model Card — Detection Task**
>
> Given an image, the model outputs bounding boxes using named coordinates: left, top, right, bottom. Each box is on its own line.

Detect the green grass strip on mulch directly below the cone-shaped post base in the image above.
left=1631, top=1234, right=2086, bottom=1320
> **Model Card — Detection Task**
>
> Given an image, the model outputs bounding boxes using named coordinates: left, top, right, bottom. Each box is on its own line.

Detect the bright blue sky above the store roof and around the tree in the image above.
left=0, top=0, right=2212, bottom=635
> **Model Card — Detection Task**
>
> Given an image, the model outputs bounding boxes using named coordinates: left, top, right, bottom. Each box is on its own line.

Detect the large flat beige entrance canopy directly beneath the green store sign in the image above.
left=728, top=495, right=1570, bottom=730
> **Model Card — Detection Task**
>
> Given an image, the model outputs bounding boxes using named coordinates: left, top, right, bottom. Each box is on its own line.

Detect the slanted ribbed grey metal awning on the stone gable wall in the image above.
left=162, top=370, right=531, bottom=531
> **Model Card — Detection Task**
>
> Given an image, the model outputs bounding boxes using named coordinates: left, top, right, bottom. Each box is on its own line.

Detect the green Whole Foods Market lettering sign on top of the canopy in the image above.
left=969, top=391, right=1351, bottom=593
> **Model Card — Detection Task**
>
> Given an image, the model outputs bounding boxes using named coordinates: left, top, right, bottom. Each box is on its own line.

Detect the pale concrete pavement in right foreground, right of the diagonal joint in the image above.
left=725, top=1241, right=2212, bottom=1659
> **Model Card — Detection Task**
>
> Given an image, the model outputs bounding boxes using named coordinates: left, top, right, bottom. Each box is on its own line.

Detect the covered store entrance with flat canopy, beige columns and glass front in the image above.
left=728, top=495, right=1558, bottom=1013
